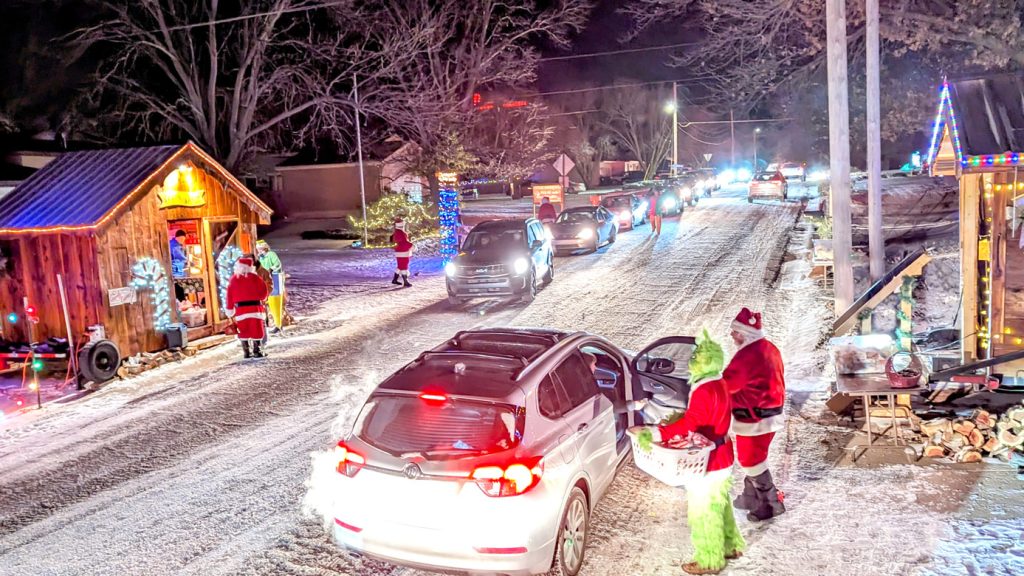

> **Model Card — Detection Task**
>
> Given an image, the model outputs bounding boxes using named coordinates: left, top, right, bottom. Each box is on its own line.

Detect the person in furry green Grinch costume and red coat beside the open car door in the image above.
left=639, top=330, right=746, bottom=574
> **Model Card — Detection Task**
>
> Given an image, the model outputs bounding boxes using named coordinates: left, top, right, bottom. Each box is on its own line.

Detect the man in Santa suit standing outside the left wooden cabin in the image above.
left=224, top=256, right=269, bottom=358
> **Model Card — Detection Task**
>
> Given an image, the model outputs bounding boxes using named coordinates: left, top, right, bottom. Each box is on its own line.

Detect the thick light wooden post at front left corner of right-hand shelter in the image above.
left=959, top=174, right=981, bottom=362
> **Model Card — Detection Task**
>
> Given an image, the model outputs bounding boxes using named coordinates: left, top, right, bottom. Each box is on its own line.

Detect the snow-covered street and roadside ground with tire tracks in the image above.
left=0, top=191, right=1024, bottom=576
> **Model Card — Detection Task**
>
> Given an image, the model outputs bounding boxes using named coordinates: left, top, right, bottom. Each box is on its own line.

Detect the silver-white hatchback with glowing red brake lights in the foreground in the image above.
left=333, top=329, right=663, bottom=576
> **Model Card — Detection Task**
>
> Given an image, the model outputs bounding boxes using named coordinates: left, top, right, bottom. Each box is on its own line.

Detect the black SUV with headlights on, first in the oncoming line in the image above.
left=444, top=218, right=555, bottom=304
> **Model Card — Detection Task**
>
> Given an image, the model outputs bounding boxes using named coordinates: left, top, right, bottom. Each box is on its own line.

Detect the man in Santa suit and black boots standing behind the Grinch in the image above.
left=722, top=307, right=785, bottom=521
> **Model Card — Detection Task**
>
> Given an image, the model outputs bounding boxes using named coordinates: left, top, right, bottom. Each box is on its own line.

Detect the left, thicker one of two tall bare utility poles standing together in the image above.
left=825, top=0, right=853, bottom=309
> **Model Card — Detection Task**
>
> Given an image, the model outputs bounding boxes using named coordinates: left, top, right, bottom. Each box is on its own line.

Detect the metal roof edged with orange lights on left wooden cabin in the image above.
left=0, top=142, right=271, bottom=234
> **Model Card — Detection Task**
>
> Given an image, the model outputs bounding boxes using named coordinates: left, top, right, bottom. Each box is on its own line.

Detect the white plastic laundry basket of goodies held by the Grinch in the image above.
left=629, top=430, right=715, bottom=486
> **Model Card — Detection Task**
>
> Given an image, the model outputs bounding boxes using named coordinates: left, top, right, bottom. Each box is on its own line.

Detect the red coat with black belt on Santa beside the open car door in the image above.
left=723, top=338, right=785, bottom=436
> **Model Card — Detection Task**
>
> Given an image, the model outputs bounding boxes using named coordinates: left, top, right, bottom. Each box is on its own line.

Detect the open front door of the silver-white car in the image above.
left=630, top=336, right=697, bottom=424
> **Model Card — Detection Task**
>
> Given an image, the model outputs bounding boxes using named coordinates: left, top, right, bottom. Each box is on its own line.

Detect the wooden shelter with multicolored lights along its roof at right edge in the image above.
left=928, top=73, right=1024, bottom=377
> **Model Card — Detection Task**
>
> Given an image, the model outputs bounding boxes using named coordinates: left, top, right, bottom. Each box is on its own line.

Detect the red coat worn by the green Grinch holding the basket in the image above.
left=657, top=375, right=732, bottom=472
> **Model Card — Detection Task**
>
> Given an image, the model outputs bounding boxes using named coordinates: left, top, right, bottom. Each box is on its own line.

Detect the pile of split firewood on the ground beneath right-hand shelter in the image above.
left=921, top=405, right=1024, bottom=462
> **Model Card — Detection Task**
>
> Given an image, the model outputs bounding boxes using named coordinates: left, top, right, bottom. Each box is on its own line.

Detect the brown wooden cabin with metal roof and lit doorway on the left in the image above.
left=0, top=142, right=270, bottom=356
